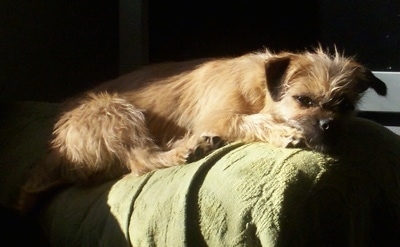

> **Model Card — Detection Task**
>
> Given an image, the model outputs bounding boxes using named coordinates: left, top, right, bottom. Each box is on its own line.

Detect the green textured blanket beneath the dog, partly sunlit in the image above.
left=0, top=103, right=400, bottom=246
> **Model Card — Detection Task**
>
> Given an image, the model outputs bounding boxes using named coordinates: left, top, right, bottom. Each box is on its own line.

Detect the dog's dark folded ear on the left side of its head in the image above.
left=265, top=56, right=290, bottom=101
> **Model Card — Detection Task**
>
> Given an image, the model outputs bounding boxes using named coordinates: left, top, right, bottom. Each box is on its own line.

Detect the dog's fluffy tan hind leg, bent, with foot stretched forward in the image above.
left=52, top=94, right=212, bottom=179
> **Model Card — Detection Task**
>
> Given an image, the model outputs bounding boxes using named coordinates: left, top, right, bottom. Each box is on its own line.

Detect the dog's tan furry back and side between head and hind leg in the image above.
left=95, top=53, right=268, bottom=140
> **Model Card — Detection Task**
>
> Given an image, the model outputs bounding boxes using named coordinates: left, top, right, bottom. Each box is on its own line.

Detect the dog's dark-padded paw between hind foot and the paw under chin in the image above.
left=186, top=134, right=226, bottom=163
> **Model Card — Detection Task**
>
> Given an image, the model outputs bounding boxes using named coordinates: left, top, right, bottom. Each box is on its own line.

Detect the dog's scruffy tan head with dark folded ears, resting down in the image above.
left=265, top=49, right=386, bottom=151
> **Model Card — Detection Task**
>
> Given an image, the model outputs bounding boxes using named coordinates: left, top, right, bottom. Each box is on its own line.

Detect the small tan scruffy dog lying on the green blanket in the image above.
left=16, top=49, right=386, bottom=211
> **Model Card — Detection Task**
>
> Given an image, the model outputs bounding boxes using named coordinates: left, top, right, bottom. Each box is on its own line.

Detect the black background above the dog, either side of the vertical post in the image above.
left=0, top=0, right=400, bottom=101
